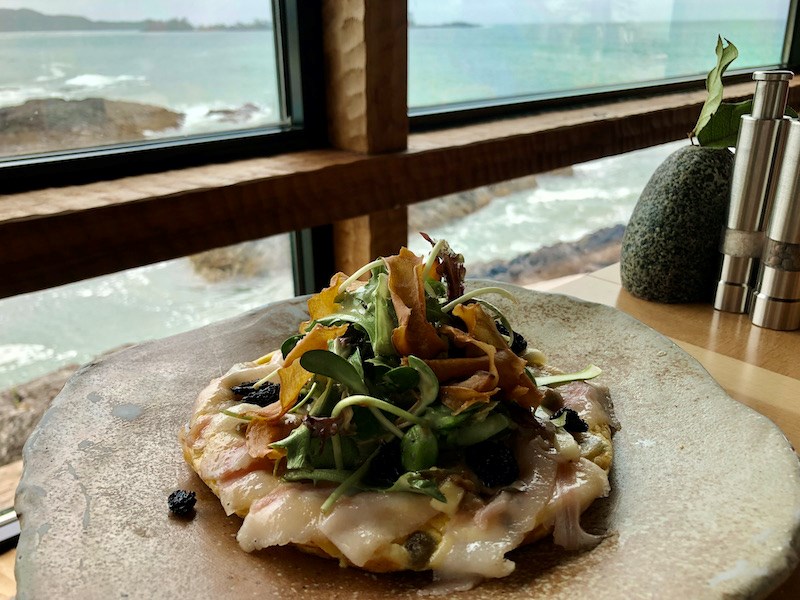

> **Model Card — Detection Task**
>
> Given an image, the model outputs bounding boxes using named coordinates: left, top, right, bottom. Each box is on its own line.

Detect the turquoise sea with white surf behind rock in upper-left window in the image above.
left=0, top=31, right=281, bottom=134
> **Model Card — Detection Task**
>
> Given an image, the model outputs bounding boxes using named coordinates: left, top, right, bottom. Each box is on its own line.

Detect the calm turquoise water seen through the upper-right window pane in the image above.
left=408, top=21, right=786, bottom=107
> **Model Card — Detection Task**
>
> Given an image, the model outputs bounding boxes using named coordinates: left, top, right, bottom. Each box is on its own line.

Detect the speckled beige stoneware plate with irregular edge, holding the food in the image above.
left=12, top=288, right=800, bottom=600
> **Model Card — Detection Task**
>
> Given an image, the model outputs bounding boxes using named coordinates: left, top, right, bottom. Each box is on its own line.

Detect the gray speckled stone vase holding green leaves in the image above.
left=620, top=145, right=733, bottom=303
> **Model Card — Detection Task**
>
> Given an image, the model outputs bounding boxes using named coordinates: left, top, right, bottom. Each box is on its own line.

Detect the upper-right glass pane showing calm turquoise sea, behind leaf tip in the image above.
left=408, top=0, right=789, bottom=107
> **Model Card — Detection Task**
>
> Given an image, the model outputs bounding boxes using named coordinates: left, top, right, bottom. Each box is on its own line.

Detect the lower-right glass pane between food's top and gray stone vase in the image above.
left=409, top=141, right=686, bottom=285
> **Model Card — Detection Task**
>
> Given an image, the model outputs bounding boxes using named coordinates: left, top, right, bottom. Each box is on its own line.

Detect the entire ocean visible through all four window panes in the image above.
left=0, top=21, right=783, bottom=390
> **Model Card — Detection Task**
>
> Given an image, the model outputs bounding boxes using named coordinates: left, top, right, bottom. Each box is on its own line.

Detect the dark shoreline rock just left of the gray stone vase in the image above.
left=469, top=225, right=625, bottom=285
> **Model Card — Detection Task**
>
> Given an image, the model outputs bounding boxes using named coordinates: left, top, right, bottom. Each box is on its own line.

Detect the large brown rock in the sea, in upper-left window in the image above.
left=0, top=98, right=183, bottom=155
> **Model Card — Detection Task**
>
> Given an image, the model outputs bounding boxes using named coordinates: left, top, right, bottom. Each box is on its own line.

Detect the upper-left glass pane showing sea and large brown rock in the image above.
left=0, top=0, right=283, bottom=158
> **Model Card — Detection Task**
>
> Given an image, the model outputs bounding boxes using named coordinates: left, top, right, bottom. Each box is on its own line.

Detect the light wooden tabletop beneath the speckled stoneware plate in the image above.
left=0, top=265, right=800, bottom=600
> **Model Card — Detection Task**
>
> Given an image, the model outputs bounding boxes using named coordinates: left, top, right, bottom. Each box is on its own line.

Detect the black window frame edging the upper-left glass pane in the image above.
left=0, top=0, right=326, bottom=194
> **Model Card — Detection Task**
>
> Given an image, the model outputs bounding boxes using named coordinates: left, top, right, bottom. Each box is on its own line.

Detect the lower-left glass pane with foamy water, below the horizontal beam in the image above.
left=0, top=234, right=294, bottom=408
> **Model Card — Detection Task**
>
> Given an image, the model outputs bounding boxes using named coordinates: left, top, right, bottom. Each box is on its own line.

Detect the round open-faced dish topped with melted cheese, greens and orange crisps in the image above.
left=180, top=240, right=617, bottom=594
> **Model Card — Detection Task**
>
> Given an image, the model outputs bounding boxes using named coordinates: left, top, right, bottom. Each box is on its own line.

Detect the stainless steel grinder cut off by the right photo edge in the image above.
left=751, top=120, right=800, bottom=330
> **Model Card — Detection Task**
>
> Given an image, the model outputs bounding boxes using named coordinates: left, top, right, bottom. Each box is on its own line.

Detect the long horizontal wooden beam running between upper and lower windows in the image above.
left=0, top=81, right=800, bottom=297
